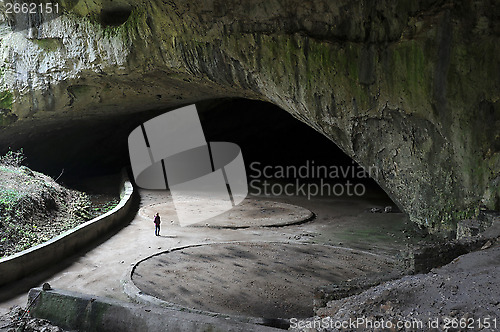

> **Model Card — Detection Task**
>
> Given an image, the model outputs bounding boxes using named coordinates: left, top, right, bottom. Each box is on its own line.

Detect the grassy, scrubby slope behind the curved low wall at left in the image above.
left=0, top=150, right=118, bottom=257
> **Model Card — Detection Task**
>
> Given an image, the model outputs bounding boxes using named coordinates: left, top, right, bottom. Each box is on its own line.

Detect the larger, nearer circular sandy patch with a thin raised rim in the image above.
left=132, top=242, right=396, bottom=318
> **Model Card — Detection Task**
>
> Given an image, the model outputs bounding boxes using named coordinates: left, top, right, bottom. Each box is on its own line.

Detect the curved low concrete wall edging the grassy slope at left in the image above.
left=0, top=178, right=134, bottom=286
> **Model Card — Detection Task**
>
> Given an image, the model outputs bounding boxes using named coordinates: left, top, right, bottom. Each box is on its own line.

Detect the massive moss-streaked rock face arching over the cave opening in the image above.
left=0, top=0, right=500, bottom=234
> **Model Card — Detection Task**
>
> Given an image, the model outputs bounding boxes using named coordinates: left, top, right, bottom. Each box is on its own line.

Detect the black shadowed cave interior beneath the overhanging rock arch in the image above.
left=5, top=99, right=387, bottom=202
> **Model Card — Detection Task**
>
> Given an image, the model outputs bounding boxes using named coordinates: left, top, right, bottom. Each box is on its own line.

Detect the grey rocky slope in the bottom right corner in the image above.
left=290, top=245, right=500, bottom=331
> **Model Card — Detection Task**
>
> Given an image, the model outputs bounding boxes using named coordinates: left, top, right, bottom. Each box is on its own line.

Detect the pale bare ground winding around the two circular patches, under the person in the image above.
left=0, top=190, right=422, bottom=326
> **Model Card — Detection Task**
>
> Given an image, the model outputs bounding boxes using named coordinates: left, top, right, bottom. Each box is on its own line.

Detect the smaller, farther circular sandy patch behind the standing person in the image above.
left=139, top=198, right=314, bottom=228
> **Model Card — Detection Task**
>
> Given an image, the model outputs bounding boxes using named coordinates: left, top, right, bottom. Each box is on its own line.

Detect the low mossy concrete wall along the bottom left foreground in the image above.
left=28, top=288, right=283, bottom=332
